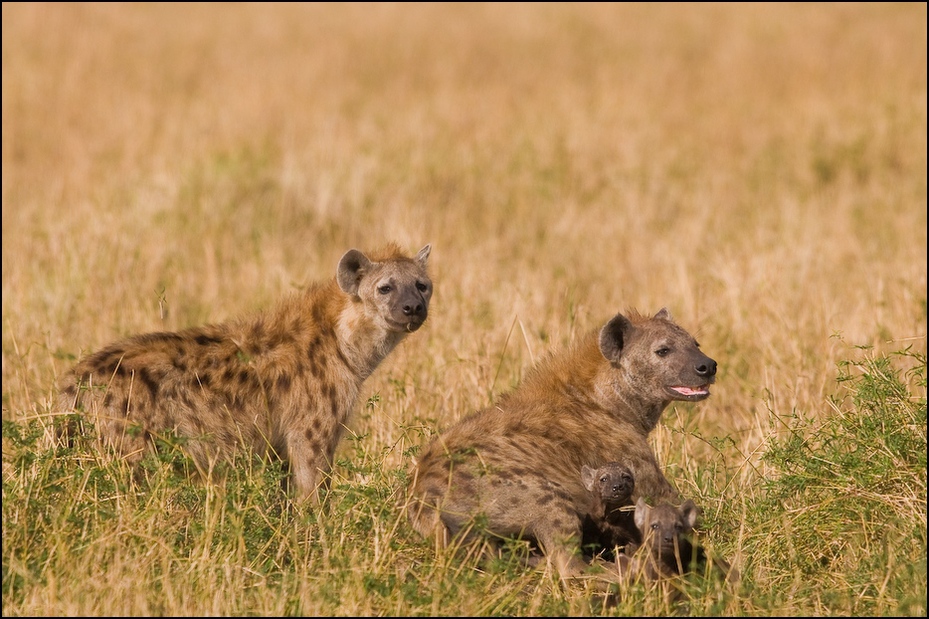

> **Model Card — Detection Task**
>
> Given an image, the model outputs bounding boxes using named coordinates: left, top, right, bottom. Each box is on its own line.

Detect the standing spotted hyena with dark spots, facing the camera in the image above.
left=58, top=244, right=432, bottom=500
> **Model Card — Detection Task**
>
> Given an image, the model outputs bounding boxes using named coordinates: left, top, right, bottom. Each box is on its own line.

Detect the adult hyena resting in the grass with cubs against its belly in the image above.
left=408, top=309, right=716, bottom=579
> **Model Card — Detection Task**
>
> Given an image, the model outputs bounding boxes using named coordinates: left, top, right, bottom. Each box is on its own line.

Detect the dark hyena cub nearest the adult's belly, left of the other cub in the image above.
left=581, top=462, right=642, bottom=560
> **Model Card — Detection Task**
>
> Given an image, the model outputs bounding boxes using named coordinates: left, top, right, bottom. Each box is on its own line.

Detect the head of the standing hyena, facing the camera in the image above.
left=336, top=245, right=432, bottom=333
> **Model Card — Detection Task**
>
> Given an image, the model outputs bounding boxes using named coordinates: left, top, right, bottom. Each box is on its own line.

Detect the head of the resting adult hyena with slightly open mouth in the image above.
left=600, top=308, right=716, bottom=403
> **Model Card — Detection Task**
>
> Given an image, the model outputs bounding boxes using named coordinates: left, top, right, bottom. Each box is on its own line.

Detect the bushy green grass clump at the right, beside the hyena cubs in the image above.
left=747, top=349, right=926, bottom=615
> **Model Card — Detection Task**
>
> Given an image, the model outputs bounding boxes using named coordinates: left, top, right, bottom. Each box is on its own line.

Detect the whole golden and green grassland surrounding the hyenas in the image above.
left=2, top=2, right=927, bottom=616
